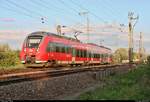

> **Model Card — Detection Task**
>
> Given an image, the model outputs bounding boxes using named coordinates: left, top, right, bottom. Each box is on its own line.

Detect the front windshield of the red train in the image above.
left=27, top=36, right=42, bottom=48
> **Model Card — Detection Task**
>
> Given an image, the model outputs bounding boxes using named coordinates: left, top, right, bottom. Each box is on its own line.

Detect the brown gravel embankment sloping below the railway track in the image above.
left=0, top=65, right=133, bottom=100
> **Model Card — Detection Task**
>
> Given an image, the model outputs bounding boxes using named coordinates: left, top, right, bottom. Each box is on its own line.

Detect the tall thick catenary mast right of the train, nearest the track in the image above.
left=128, top=12, right=139, bottom=64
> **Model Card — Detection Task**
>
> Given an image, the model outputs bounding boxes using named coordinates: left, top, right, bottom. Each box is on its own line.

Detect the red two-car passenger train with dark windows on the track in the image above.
left=20, top=32, right=112, bottom=66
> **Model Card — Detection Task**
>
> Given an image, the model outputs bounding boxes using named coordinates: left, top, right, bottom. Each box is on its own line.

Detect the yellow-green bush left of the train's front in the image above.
left=0, top=51, right=19, bottom=67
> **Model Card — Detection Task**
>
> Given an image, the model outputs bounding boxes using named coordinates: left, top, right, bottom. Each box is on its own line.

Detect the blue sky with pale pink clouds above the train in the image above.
left=0, top=0, right=150, bottom=53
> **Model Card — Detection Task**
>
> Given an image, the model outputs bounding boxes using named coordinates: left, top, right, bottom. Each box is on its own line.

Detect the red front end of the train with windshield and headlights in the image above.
left=20, top=34, right=44, bottom=66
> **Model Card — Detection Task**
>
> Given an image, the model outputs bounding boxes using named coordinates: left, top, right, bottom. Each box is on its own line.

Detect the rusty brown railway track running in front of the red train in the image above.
left=0, top=64, right=136, bottom=86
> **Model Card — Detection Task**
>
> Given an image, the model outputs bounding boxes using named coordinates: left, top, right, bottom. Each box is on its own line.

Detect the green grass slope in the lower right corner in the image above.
left=78, top=65, right=150, bottom=100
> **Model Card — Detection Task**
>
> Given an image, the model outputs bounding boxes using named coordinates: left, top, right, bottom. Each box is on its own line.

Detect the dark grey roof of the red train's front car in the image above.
left=29, top=31, right=82, bottom=43
